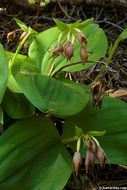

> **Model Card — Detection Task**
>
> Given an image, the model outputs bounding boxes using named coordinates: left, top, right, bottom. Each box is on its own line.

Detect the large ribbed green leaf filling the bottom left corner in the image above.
left=0, top=116, right=72, bottom=190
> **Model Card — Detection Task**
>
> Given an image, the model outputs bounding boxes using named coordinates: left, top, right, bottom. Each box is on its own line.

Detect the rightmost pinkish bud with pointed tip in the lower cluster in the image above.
left=96, top=146, right=108, bottom=168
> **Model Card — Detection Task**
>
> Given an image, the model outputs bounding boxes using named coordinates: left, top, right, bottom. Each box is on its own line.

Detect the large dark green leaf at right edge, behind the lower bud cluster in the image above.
left=63, top=96, right=127, bottom=165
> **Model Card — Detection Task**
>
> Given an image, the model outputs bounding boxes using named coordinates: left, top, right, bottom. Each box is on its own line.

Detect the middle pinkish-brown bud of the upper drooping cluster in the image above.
left=64, top=41, right=74, bottom=61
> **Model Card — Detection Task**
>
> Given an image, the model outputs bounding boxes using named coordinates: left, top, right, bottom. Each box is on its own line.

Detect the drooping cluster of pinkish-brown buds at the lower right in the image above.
left=72, top=137, right=109, bottom=176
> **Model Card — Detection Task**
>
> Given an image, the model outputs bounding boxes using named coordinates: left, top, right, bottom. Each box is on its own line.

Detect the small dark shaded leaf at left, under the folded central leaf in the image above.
left=2, top=89, right=35, bottom=119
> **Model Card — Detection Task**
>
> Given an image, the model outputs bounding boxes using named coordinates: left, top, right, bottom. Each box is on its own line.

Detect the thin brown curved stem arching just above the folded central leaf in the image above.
left=52, top=61, right=107, bottom=78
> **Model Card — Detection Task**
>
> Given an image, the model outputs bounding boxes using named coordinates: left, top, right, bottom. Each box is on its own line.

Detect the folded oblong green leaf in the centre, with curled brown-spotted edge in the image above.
left=12, top=65, right=88, bottom=116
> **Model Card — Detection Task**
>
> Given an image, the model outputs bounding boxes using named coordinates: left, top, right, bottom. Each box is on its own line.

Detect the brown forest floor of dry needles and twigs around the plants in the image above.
left=0, top=0, right=127, bottom=190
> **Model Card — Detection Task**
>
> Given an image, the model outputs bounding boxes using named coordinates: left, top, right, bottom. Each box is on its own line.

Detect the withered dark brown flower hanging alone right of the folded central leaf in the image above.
left=90, top=79, right=105, bottom=109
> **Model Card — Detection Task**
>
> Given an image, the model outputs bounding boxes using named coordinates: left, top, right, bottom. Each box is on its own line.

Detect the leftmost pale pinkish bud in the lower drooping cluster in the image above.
left=72, top=152, right=82, bottom=176
